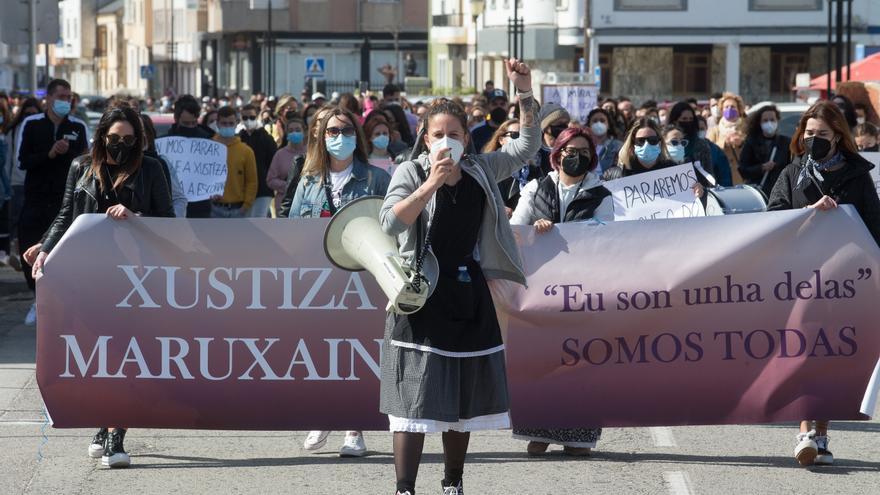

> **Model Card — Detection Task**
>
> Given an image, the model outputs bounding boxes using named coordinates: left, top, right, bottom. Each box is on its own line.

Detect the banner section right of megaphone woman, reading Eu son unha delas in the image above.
left=496, top=207, right=880, bottom=427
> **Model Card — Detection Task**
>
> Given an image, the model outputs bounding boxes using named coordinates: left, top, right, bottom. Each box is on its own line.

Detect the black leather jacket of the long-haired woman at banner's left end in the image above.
left=40, top=156, right=174, bottom=253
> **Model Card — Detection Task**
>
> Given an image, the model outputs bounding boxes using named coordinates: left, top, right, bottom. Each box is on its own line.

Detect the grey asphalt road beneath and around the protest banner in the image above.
left=0, top=269, right=880, bottom=495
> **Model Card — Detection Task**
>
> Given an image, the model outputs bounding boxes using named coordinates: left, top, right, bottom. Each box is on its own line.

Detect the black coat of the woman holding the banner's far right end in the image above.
left=767, top=152, right=880, bottom=244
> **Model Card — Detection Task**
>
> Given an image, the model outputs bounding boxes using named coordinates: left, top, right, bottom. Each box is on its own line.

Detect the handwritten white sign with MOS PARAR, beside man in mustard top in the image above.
left=156, top=136, right=227, bottom=202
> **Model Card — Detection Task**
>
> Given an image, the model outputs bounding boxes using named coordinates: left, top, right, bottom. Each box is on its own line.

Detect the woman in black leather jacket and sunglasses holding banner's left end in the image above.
left=25, top=104, right=174, bottom=467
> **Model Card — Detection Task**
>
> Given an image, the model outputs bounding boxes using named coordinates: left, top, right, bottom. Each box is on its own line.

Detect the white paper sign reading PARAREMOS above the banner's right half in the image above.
left=604, top=163, right=706, bottom=221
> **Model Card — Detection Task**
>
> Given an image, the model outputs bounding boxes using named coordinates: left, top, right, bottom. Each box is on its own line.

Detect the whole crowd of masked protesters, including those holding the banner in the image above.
left=0, top=67, right=880, bottom=494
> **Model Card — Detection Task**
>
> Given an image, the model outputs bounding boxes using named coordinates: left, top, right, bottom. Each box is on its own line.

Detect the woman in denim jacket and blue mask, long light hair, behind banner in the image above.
left=289, top=108, right=391, bottom=218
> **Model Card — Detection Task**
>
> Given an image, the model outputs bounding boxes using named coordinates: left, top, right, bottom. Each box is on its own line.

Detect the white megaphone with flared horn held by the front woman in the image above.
left=324, top=196, right=440, bottom=314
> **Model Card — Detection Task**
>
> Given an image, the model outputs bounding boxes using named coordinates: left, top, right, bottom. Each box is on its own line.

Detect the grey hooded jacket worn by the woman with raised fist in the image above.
left=380, top=98, right=541, bottom=285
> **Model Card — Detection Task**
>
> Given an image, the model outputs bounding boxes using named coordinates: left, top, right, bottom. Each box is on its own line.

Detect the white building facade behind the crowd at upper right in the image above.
left=431, top=0, right=880, bottom=101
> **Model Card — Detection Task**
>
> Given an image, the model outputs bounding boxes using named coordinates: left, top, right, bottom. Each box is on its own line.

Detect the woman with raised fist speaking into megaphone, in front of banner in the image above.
left=380, top=59, right=541, bottom=494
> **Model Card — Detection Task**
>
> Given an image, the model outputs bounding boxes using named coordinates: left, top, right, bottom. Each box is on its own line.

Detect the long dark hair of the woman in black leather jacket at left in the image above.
left=89, top=103, right=145, bottom=190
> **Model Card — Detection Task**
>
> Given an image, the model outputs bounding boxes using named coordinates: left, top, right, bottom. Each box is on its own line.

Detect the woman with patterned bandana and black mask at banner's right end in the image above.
left=768, top=101, right=880, bottom=466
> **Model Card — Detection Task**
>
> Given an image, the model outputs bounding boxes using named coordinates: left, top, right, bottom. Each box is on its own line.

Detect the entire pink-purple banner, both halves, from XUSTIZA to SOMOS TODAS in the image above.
left=37, top=208, right=880, bottom=430
